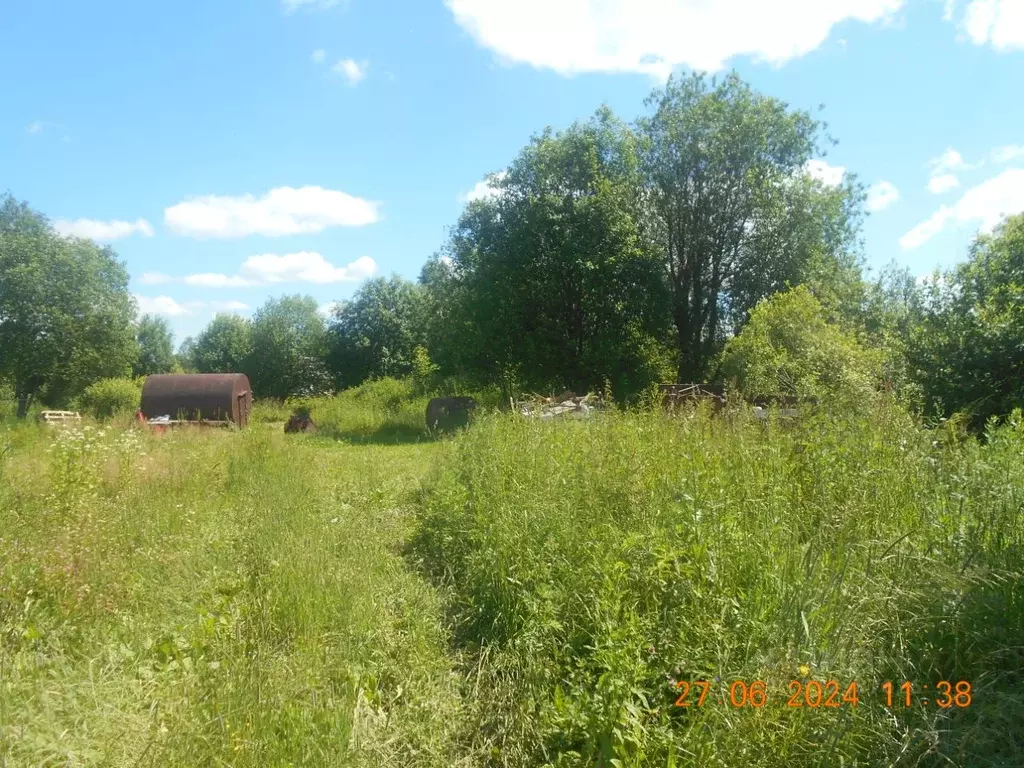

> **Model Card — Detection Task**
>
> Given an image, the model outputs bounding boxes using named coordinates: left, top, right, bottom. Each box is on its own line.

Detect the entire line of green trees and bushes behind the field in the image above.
left=0, top=75, right=1024, bottom=423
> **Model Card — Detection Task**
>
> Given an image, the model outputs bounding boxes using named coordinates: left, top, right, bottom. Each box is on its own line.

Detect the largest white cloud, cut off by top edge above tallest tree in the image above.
left=445, top=0, right=905, bottom=78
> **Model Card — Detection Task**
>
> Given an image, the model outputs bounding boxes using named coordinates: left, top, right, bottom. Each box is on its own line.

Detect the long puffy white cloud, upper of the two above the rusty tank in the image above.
left=164, top=186, right=380, bottom=238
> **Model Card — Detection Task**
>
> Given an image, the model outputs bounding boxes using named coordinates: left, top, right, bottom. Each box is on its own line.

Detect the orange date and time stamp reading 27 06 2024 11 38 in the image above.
left=675, top=680, right=974, bottom=710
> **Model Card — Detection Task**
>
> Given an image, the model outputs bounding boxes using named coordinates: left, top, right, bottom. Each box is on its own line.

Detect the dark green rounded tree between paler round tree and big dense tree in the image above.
left=329, top=275, right=426, bottom=387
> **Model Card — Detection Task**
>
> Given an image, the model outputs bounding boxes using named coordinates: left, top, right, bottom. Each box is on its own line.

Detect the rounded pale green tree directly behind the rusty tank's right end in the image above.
left=245, top=296, right=332, bottom=397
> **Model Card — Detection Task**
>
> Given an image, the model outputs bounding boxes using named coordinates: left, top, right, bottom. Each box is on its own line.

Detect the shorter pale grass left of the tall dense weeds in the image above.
left=0, top=427, right=471, bottom=767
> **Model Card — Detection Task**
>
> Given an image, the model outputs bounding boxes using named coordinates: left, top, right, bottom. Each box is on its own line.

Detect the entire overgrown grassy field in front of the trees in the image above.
left=0, top=393, right=1024, bottom=768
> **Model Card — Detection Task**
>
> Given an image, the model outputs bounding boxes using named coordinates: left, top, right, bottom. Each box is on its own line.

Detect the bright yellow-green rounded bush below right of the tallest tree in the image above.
left=721, top=286, right=883, bottom=401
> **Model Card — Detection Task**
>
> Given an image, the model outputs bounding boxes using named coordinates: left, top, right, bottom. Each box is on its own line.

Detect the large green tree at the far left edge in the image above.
left=0, top=195, right=137, bottom=417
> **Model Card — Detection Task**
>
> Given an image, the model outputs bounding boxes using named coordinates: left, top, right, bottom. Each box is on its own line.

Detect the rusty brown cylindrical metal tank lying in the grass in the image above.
left=140, top=374, right=253, bottom=427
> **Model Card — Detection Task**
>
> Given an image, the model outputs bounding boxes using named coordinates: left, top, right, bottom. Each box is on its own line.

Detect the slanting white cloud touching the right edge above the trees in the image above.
left=899, top=168, right=1024, bottom=250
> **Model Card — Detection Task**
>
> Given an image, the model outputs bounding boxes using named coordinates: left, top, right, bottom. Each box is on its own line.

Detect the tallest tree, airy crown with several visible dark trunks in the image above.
left=638, top=75, right=863, bottom=381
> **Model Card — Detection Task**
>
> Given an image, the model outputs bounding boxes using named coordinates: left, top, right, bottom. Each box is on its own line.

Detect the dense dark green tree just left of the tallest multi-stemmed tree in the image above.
left=446, top=109, right=671, bottom=403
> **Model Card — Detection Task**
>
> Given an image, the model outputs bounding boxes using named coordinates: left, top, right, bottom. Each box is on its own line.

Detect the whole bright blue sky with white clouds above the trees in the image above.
left=0, top=0, right=1024, bottom=342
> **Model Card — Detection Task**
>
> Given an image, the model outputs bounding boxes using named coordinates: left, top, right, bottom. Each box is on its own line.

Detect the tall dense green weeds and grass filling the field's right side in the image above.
left=415, top=408, right=1024, bottom=766
